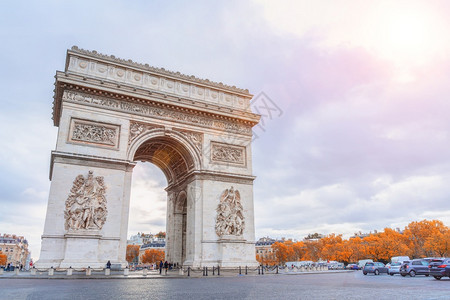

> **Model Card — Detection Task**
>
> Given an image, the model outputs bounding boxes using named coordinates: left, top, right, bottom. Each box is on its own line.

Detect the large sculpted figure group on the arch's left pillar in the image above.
left=64, top=171, right=108, bottom=231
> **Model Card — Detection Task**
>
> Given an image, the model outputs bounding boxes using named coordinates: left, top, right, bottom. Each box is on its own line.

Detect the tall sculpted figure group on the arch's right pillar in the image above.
left=216, top=187, right=245, bottom=237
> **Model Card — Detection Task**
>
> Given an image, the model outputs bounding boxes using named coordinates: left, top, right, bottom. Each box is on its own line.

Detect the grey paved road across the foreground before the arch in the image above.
left=0, top=271, right=450, bottom=299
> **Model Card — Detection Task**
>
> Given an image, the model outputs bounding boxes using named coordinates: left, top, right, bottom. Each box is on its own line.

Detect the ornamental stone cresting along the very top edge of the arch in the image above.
left=71, top=46, right=250, bottom=96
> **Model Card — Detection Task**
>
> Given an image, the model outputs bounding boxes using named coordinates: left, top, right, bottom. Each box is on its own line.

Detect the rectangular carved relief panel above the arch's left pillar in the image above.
left=69, top=119, right=120, bottom=148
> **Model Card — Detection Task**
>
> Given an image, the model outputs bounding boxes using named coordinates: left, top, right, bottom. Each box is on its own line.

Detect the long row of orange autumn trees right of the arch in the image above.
left=268, top=220, right=450, bottom=264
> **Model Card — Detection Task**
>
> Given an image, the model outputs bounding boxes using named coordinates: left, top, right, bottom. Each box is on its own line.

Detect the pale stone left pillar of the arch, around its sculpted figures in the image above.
left=36, top=154, right=134, bottom=268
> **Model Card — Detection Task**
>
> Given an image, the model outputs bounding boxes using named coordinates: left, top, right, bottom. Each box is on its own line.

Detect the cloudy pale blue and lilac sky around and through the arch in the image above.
left=0, top=0, right=450, bottom=260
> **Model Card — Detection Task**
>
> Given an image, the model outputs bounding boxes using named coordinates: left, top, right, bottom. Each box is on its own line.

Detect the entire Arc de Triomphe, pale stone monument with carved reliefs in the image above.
left=36, top=47, right=259, bottom=268
